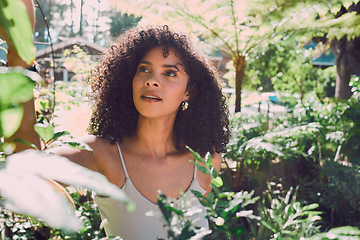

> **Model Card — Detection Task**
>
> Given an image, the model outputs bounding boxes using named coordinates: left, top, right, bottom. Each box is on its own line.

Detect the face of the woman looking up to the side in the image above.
left=132, top=46, right=189, bottom=118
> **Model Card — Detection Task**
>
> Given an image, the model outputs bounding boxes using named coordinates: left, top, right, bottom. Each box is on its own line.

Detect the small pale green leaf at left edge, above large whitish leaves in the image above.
left=0, top=105, right=24, bottom=137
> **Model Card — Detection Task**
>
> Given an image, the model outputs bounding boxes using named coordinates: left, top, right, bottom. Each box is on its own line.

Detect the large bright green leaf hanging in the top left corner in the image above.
left=0, top=0, right=36, bottom=65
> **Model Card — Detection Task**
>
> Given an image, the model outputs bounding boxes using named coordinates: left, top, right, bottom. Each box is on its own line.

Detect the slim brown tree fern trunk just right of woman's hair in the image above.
left=234, top=54, right=246, bottom=112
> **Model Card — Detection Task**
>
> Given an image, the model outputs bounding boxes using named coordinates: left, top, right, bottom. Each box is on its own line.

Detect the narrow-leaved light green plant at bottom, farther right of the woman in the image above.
left=255, top=182, right=321, bottom=239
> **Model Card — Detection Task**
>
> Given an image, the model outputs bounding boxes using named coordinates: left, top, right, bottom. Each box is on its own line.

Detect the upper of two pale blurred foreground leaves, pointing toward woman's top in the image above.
left=6, top=150, right=135, bottom=211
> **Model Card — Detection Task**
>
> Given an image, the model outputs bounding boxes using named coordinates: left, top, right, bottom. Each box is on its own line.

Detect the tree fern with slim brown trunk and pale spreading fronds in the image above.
left=110, top=0, right=288, bottom=112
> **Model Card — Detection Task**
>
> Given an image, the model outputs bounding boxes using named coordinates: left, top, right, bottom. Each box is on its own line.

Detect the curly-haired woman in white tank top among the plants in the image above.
left=54, top=26, right=229, bottom=240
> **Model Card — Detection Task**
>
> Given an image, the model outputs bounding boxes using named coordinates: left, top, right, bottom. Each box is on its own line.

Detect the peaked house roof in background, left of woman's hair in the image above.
left=36, top=36, right=107, bottom=58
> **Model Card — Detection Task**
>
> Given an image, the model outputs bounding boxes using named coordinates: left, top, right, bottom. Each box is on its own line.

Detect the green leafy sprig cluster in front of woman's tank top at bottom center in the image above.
left=153, top=148, right=259, bottom=240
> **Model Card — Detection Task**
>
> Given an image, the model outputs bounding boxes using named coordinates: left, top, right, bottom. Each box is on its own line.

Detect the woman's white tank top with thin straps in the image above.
left=94, top=144, right=208, bottom=240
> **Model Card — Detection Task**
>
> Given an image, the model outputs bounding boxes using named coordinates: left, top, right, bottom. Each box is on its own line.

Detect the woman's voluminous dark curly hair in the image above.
left=88, top=26, right=230, bottom=156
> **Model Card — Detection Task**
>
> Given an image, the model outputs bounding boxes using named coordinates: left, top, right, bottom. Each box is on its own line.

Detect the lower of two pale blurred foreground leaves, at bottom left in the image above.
left=0, top=170, right=81, bottom=232
